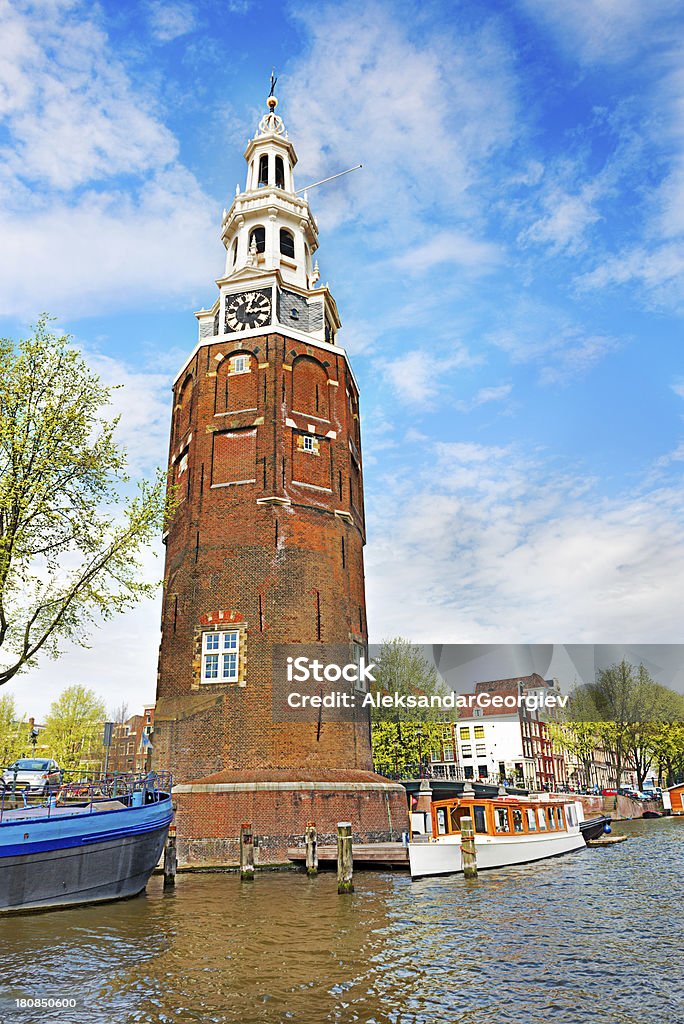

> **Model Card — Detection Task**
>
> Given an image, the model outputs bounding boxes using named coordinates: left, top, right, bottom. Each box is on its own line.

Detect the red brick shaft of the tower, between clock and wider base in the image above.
left=154, top=334, right=372, bottom=781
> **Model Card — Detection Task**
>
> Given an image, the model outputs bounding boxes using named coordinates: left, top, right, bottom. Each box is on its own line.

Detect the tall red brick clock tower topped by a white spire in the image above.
left=154, top=96, right=407, bottom=864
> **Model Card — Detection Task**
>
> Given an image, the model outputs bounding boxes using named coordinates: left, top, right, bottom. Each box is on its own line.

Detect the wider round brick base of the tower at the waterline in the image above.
left=173, top=770, right=409, bottom=867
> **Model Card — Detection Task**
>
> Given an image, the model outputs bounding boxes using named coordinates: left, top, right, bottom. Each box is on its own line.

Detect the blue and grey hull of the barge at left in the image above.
left=0, top=802, right=171, bottom=913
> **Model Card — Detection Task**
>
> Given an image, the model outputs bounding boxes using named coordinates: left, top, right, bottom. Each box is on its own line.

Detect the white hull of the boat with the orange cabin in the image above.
left=409, top=828, right=586, bottom=879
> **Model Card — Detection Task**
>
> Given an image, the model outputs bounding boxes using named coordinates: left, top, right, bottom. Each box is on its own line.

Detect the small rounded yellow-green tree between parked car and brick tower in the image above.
left=40, top=686, right=106, bottom=771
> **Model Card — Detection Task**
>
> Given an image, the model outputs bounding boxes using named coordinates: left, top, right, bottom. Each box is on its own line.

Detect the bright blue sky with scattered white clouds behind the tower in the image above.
left=0, top=0, right=684, bottom=715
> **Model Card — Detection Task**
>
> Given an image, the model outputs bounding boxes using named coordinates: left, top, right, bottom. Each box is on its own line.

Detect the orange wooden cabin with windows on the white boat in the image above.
left=432, top=797, right=579, bottom=839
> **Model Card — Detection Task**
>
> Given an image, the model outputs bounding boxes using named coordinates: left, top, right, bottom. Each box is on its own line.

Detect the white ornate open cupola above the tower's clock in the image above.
left=221, top=96, right=318, bottom=289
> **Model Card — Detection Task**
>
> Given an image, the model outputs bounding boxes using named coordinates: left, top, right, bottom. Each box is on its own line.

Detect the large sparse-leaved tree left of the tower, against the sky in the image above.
left=0, top=317, right=165, bottom=685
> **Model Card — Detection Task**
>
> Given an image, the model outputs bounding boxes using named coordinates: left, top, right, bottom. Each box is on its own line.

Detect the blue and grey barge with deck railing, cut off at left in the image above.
left=0, top=772, right=173, bottom=913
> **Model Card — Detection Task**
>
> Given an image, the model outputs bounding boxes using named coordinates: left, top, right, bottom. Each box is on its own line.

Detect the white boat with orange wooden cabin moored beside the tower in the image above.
left=409, top=795, right=585, bottom=879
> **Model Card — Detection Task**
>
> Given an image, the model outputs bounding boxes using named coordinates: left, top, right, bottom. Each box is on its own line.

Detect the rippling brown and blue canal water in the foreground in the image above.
left=0, top=818, right=684, bottom=1024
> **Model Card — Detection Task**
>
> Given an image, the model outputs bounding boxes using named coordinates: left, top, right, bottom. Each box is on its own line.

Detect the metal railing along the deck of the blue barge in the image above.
left=0, top=769, right=172, bottom=822
